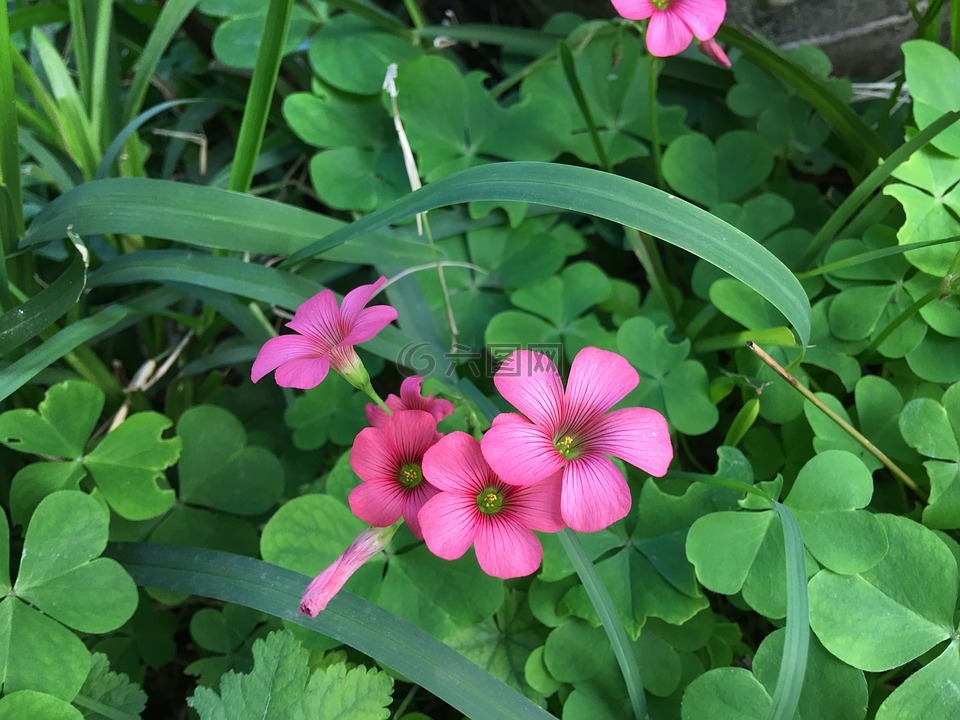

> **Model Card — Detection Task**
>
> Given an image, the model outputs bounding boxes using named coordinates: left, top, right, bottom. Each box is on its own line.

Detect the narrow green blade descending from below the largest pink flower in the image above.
left=557, top=528, right=648, bottom=720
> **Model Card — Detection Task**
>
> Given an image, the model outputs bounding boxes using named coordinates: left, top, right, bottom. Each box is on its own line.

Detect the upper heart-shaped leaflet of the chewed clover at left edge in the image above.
left=0, top=380, right=104, bottom=460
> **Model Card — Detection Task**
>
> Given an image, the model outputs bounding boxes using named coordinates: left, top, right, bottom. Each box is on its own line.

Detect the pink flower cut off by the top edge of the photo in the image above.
left=613, top=0, right=727, bottom=57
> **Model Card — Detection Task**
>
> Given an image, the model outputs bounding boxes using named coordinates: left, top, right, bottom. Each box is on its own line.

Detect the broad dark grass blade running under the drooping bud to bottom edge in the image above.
left=107, top=543, right=553, bottom=720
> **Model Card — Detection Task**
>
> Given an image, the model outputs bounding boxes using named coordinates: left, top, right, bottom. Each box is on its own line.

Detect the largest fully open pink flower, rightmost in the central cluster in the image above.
left=481, top=347, right=673, bottom=532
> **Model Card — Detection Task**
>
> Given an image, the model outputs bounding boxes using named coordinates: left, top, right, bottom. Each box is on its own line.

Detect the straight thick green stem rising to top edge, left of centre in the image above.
left=227, top=0, right=293, bottom=192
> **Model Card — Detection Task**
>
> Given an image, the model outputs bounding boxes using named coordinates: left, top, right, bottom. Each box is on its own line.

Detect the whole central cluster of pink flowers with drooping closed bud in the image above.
left=252, top=278, right=673, bottom=617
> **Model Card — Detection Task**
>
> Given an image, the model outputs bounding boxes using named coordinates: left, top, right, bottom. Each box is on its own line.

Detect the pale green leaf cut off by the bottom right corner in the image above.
left=876, top=641, right=960, bottom=720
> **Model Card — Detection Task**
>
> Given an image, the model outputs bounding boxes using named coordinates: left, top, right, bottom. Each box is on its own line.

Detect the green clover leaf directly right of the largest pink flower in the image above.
left=617, top=317, right=719, bottom=435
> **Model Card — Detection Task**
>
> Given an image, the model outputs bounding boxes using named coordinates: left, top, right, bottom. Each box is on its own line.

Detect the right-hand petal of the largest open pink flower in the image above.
left=590, top=408, right=673, bottom=477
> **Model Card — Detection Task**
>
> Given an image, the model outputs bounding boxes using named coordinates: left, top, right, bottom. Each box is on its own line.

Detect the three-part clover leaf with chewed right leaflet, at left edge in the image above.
left=0, top=380, right=180, bottom=523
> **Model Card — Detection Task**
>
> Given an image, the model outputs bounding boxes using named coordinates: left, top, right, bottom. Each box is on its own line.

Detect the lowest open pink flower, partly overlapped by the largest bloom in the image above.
left=420, top=432, right=563, bottom=578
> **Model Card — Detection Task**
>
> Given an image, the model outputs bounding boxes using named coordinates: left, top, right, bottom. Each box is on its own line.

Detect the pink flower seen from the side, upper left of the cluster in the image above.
left=250, top=277, right=397, bottom=390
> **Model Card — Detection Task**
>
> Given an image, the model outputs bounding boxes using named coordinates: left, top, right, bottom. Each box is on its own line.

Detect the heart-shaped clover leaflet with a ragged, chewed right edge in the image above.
left=83, top=412, right=180, bottom=520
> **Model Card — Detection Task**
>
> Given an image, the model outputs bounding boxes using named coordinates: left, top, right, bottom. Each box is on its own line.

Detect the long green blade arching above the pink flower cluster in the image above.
left=286, top=164, right=810, bottom=354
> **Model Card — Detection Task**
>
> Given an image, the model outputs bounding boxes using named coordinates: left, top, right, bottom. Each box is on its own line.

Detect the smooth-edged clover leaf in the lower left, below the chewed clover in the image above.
left=0, top=490, right=138, bottom=701
